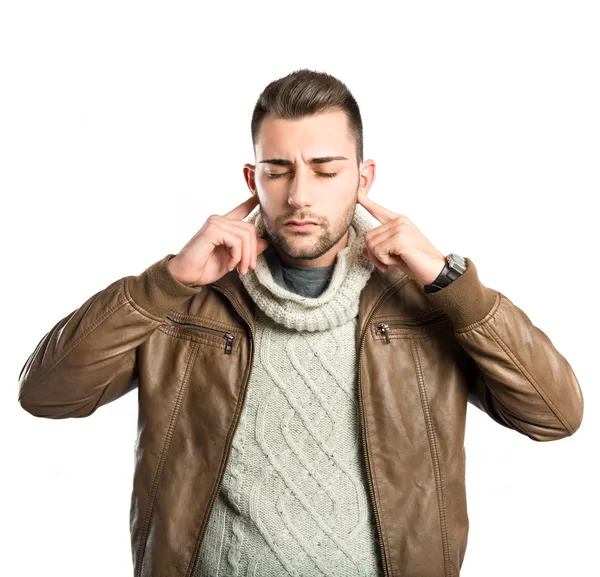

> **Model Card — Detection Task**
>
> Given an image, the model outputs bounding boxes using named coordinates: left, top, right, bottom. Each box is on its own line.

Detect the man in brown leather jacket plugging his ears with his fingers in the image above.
left=19, top=69, right=583, bottom=577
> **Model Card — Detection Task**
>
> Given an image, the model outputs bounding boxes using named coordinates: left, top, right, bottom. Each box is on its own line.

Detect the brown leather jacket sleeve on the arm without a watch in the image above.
left=18, top=254, right=203, bottom=419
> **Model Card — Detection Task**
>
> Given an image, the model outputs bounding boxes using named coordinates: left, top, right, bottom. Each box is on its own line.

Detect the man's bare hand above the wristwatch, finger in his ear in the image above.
left=358, top=192, right=446, bottom=285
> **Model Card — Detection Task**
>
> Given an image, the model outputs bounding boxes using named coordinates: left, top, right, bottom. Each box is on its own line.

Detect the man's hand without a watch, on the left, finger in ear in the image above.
left=168, top=194, right=268, bottom=287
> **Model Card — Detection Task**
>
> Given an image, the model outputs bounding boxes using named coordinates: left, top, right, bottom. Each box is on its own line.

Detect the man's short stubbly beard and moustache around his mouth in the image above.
left=260, top=181, right=360, bottom=261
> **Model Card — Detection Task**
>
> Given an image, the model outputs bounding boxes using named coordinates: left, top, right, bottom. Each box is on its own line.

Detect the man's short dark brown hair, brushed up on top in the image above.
left=251, top=68, right=363, bottom=162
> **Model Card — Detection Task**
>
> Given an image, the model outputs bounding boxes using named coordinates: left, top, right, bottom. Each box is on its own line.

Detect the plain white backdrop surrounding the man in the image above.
left=0, top=0, right=600, bottom=577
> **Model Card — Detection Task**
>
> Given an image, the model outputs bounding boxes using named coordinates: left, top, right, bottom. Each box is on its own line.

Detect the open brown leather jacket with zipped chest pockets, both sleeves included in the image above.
left=19, top=255, right=583, bottom=577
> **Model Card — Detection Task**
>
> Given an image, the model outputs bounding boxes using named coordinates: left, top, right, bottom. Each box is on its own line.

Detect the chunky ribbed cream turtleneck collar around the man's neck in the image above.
left=238, top=204, right=376, bottom=331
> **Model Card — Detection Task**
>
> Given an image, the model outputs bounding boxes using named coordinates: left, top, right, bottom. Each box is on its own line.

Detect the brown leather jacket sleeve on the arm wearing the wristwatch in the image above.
left=424, top=258, right=583, bottom=441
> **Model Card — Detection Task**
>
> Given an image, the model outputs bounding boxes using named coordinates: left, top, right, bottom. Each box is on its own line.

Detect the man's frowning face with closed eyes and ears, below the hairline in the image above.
left=244, top=110, right=375, bottom=266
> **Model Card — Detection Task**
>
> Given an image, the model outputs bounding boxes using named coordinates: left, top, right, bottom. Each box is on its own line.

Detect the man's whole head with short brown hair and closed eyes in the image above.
left=244, top=69, right=375, bottom=266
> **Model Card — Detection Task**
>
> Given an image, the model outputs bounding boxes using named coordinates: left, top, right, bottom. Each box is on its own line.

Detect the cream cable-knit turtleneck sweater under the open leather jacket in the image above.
left=193, top=205, right=382, bottom=577
